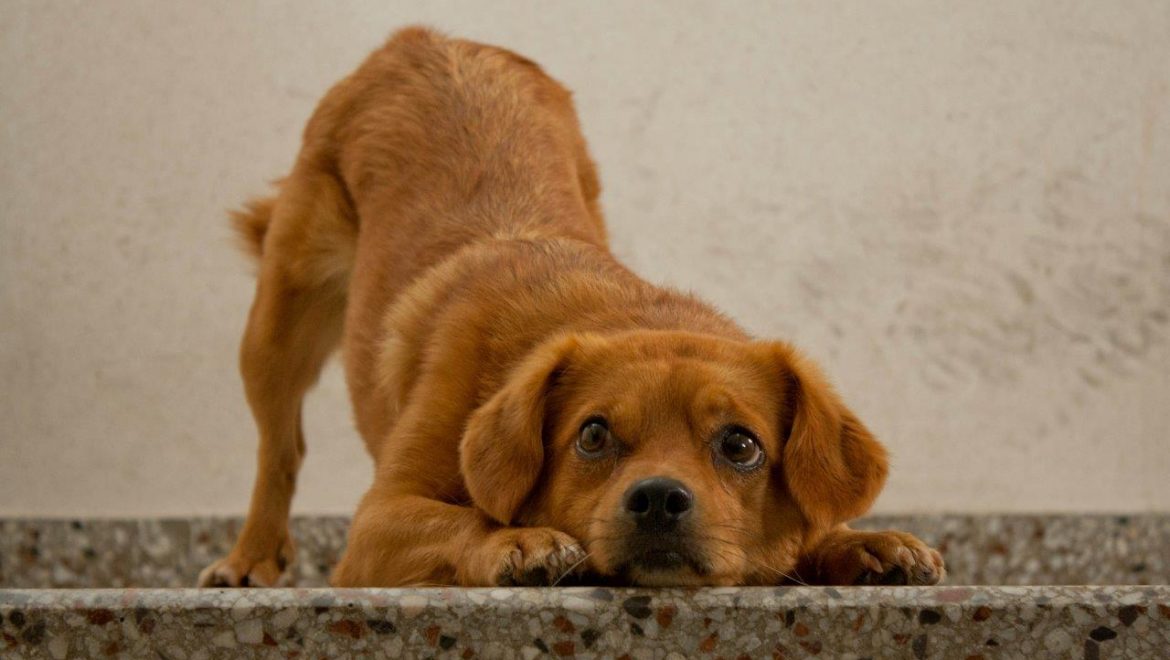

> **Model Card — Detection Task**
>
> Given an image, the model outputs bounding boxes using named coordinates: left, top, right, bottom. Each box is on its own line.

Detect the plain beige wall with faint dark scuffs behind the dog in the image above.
left=0, top=0, right=1170, bottom=515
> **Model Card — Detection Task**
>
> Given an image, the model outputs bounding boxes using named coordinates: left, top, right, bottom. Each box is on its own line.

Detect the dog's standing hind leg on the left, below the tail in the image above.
left=199, top=165, right=357, bottom=586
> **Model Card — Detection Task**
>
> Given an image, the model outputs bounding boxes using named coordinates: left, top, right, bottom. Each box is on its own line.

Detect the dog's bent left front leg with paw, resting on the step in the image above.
left=330, top=388, right=585, bottom=587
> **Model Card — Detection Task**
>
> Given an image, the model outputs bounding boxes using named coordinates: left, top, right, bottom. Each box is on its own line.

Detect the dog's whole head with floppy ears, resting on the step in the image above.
left=462, top=331, right=886, bottom=585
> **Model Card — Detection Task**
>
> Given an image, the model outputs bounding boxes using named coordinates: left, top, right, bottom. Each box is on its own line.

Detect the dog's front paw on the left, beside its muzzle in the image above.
left=475, top=527, right=586, bottom=586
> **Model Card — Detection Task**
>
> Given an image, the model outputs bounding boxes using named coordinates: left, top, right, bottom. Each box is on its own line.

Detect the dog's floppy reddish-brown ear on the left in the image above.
left=459, top=337, right=577, bottom=524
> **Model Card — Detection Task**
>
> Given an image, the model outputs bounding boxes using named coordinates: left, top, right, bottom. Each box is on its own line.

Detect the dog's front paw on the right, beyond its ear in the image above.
left=813, top=530, right=947, bottom=585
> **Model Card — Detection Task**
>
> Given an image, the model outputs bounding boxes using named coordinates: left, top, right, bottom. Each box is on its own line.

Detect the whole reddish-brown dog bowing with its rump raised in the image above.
left=200, top=28, right=943, bottom=586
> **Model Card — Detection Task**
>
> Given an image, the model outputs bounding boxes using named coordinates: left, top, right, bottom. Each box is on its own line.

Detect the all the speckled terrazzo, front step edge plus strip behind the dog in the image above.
left=0, top=515, right=1170, bottom=659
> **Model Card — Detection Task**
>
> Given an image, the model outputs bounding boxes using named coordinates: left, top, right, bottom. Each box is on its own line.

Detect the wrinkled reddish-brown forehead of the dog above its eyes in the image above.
left=561, top=337, right=779, bottom=434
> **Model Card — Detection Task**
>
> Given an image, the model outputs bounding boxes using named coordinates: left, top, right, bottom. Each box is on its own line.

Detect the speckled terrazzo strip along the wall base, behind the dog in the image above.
left=0, top=514, right=1170, bottom=589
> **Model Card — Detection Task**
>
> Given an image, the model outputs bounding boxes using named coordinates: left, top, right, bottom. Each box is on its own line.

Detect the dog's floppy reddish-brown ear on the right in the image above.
left=770, top=343, right=888, bottom=527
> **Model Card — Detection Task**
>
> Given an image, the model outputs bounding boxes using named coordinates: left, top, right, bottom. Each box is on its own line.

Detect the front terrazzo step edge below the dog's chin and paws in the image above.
left=0, top=586, right=1170, bottom=659
